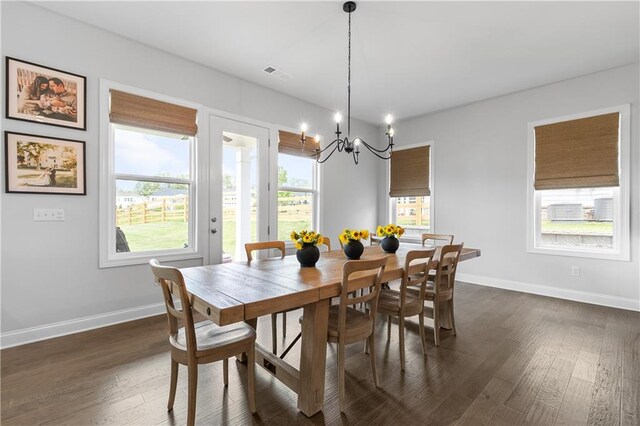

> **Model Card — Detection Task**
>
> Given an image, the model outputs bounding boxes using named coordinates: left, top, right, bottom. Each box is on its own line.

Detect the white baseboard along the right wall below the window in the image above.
left=456, top=273, right=640, bottom=311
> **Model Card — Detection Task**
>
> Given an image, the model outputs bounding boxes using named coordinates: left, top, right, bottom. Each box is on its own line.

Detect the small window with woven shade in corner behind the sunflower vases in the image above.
left=389, top=143, right=433, bottom=239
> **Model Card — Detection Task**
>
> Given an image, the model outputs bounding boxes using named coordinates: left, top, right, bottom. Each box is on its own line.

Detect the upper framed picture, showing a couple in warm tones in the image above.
left=5, top=57, right=87, bottom=130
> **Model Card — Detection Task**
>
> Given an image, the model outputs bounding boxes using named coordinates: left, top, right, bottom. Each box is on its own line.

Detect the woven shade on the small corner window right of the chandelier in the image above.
left=389, top=146, right=431, bottom=197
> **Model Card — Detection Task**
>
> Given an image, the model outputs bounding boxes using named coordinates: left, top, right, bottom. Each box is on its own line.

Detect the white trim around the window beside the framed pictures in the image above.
left=98, top=79, right=203, bottom=268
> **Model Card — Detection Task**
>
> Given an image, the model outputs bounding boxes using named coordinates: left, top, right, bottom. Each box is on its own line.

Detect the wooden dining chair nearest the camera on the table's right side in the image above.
left=327, top=256, right=387, bottom=412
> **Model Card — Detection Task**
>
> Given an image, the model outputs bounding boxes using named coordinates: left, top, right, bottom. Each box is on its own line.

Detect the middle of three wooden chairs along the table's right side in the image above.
left=378, top=249, right=436, bottom=372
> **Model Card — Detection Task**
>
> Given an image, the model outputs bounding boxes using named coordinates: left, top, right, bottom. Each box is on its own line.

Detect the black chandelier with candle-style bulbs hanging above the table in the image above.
left=300, top=1, right=394, bottom=164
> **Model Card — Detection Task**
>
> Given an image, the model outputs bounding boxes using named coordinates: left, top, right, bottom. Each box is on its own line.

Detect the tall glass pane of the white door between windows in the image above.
left=222, top=132, right=258, bottom=262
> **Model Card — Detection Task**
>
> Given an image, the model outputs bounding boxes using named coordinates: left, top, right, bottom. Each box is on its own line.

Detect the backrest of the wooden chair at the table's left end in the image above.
left=149, top=259, right=197, bottom=354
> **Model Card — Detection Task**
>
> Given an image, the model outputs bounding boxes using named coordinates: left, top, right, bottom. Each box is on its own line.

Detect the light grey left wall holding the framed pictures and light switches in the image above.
left=0, top=2, right=378, bottom=346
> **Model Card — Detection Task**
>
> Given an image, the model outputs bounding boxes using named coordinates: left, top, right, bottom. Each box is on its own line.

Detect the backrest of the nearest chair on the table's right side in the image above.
left=338, top=256, right=388, bottom=338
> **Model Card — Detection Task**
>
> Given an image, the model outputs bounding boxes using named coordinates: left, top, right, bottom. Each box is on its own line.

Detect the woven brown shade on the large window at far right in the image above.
left=534, top=112, right=620, bottom=190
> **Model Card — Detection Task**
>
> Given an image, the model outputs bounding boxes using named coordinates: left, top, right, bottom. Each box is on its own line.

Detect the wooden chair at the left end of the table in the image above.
left=149, top=259, right=256, bottom=425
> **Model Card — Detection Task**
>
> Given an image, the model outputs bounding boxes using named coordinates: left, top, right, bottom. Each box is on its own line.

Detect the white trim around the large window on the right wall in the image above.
left=526, top=104, right=631, bottom=262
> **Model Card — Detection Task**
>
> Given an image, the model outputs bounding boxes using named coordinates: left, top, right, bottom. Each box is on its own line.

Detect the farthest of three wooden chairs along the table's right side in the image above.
left=407, top=243, right=464, bottom=346
